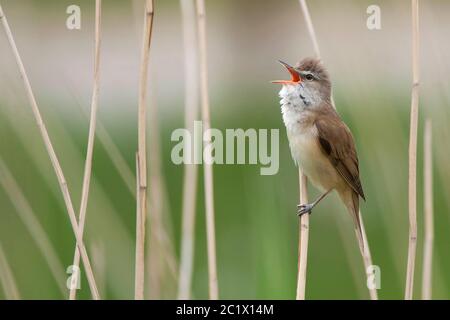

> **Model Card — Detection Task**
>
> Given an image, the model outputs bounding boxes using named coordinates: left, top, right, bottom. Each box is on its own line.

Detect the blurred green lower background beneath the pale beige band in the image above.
left=0, top=83, right=450, bottom=299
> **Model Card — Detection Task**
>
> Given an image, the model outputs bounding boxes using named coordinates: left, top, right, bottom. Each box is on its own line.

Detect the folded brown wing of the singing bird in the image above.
left=315, top=115, right=365, bottom=200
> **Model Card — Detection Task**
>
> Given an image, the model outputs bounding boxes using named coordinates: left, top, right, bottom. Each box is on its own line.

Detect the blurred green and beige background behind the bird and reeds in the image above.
left=0, top=0, right=450, bottom=299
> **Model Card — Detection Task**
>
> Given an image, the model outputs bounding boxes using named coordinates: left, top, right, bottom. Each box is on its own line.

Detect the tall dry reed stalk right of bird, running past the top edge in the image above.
left=405, top=0, right=419, bottom=300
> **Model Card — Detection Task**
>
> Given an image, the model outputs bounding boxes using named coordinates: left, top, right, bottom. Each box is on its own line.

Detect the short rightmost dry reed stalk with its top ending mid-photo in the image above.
left=422, top=119, right=434, bottom=300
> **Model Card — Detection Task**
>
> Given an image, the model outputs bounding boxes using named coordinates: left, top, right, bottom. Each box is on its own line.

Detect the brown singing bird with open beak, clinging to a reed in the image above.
left=272, top=58, right=365, bottom=252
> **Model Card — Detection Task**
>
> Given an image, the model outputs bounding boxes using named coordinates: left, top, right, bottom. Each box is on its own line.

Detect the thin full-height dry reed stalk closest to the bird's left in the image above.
left=196, top=0, right=219, bottom=300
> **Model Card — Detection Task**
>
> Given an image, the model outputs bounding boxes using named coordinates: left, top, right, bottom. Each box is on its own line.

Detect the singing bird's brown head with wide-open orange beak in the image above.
left=272, top=58, right=331, bottom=107
